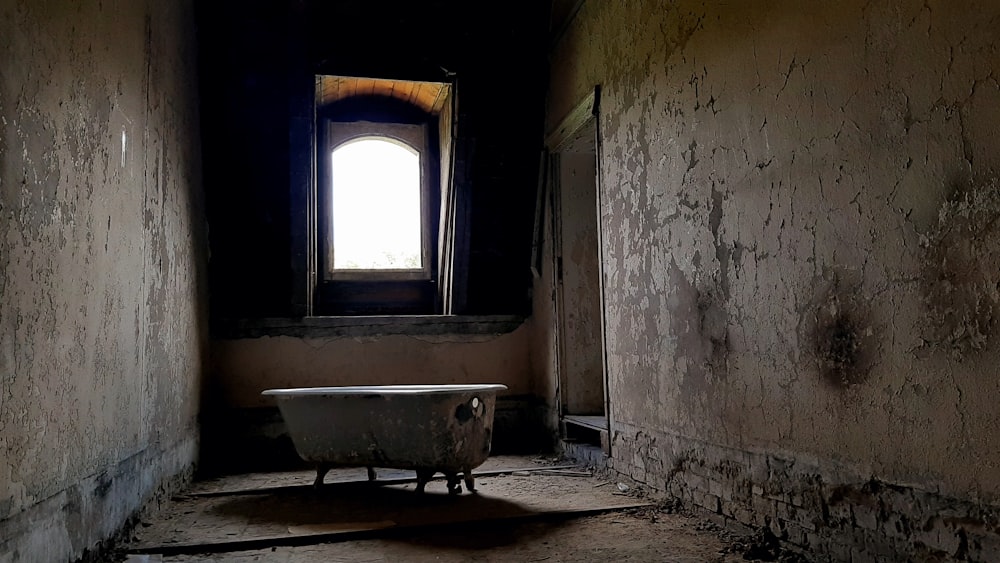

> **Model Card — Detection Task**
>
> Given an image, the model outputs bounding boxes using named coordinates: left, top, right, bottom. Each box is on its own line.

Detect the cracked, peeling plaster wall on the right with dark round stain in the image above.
left=547, top=0, right=1000, bottom=558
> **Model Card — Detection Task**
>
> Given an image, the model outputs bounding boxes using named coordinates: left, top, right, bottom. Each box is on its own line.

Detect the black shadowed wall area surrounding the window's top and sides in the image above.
left=195, top=0, right=549, bottom=319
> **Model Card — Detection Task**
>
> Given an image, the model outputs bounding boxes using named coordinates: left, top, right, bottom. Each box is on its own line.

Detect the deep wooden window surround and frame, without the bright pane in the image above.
left=306, top=75, right=460, bottom=315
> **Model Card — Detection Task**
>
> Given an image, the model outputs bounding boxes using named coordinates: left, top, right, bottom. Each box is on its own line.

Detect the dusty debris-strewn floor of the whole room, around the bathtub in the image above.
left=109, top=457, right=800, bottom=563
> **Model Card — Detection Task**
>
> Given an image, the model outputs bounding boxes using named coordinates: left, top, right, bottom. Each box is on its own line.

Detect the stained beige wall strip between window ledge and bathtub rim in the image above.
left=212, top=328, right=536, bottom=408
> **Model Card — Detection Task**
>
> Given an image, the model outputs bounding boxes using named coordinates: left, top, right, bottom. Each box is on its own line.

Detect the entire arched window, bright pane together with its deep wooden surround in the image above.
left=305, top=75, right=456, bottom=315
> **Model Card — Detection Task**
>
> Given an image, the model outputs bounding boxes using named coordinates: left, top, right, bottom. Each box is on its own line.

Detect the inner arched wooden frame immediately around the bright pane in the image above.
left=317, top=123, right=437, bottom=282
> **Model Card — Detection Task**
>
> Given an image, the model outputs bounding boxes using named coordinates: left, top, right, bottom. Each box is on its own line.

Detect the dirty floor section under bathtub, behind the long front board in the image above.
left=129, top=464, right=649, bottom=554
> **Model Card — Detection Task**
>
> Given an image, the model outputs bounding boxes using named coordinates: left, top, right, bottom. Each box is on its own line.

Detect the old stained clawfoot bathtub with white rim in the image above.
left=262, top=385, right=507, bottom=494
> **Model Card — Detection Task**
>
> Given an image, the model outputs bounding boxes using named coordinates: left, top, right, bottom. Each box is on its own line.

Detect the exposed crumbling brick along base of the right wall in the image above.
left=609, top=428, right=1000, bottom=562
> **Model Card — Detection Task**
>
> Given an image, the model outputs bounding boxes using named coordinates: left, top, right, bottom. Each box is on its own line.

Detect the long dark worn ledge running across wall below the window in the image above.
left=213, top=315, right=525, bottom=340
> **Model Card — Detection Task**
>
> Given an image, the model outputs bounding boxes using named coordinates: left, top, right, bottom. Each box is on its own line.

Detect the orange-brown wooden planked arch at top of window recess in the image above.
left=316, top=76, right=451, bottom=115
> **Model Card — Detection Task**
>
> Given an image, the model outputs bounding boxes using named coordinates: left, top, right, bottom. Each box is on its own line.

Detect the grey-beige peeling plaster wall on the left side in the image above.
left=0, top=0, right=207, bottom=561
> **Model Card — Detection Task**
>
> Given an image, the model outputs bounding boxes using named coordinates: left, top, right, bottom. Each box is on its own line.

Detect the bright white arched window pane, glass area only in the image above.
left=332, top=137, right=423, bottom=270
